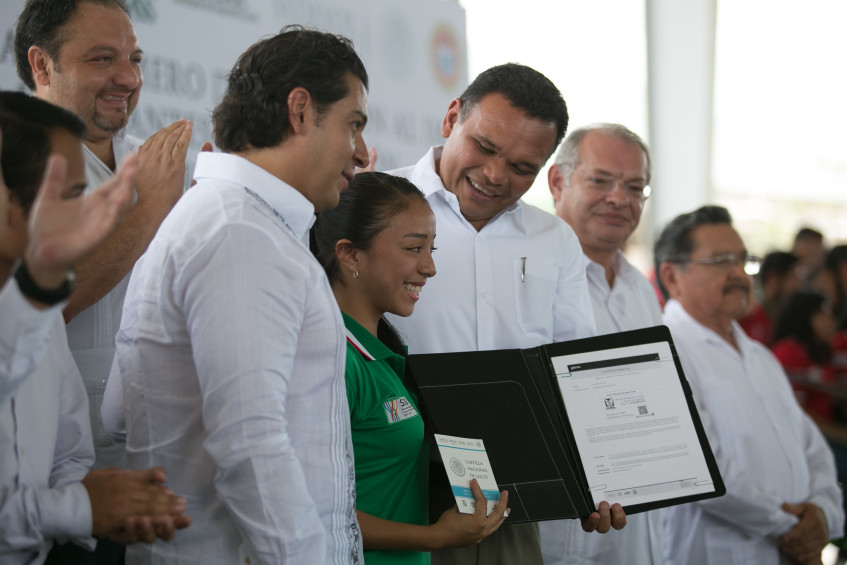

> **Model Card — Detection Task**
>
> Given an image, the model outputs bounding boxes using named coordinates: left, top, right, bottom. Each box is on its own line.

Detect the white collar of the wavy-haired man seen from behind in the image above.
left=194, top=151, right=315, bottom=240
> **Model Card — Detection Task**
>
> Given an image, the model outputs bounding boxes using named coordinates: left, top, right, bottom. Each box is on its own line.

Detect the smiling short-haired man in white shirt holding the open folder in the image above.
left=391, top=63, right=626, bottom=565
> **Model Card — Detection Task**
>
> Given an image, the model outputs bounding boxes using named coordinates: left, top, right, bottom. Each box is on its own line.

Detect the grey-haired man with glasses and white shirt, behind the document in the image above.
left=539, top=123, right=662, bottom=565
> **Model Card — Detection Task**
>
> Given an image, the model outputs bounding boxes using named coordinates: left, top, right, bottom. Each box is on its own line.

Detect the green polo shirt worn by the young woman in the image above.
left=344, top=314, right=429, bottom=565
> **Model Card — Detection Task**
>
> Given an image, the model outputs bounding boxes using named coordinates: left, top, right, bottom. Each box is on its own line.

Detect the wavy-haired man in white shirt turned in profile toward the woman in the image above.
left=104, top=27, right=368, bottom=565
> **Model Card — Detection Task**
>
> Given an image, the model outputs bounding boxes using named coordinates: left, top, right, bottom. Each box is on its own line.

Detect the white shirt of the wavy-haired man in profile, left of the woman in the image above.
left=110, top=153, right=361, bottom=565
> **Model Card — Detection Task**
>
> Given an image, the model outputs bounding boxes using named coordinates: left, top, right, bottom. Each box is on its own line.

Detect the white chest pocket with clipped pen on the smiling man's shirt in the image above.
left=513, top=257, right=559, bottom=343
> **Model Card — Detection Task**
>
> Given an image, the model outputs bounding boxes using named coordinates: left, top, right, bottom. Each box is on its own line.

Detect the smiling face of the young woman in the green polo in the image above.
left=356, top=200, right=435, bottom=325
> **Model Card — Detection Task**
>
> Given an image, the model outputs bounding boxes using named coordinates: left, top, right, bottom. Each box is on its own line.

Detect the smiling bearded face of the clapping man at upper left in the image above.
left=30, top=2, right=143, bottom=142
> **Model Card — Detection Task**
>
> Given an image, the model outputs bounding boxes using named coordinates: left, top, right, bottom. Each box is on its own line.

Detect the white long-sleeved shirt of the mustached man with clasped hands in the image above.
left=663, top=300, right=844, bottom=565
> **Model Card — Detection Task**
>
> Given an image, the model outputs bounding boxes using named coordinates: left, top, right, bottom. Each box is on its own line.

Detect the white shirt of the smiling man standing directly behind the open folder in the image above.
left=390, top=147, right=595, bottom=353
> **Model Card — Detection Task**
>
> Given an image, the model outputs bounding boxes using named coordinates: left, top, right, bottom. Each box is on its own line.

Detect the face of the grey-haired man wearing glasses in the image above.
left=548, top=131, right=647, bottom=260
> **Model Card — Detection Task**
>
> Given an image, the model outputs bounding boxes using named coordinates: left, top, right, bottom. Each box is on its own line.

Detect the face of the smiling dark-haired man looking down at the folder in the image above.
left=436, top=94, right=556, bottom=230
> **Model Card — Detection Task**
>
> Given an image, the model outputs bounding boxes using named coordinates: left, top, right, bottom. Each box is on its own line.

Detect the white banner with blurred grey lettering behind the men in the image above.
left=0, top=0, right=468, bottom=174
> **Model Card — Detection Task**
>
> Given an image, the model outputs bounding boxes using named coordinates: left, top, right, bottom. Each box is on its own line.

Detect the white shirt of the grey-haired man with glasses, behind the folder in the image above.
left=538, top=251, right=664, bottom=565
